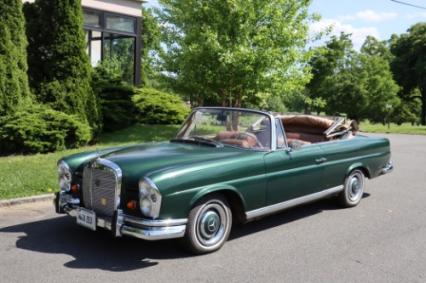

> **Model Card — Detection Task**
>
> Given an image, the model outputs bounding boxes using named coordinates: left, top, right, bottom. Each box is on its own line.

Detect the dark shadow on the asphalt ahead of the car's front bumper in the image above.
left=0, top=216, right=181, bottom=272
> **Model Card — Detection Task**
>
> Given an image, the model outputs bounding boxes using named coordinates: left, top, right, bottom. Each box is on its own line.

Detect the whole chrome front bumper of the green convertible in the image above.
left=55, top=193, right=187, bottom=241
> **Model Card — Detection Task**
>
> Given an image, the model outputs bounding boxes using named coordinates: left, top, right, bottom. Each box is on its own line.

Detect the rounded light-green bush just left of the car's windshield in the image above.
left=133, top=88, right=189, bottom=124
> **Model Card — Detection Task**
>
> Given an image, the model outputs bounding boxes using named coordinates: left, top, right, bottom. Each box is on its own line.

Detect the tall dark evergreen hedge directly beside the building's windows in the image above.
left=24, top=0, right=100, bottom=130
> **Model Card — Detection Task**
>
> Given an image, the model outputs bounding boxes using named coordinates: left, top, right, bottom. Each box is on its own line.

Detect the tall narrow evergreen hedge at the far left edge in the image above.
left=0, top=0, right=30, bottom=116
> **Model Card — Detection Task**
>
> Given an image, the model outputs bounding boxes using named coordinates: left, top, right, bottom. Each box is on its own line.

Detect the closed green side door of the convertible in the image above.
left=264, top=120, right=325, bottom=205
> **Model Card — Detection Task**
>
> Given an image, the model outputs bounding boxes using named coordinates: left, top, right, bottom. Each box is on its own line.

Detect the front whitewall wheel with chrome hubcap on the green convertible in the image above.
left=183, top=195, right=232, bottom=254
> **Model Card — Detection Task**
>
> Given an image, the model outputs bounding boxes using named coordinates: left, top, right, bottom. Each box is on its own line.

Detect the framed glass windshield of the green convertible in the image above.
left=176, top=109, right=271, bottom=150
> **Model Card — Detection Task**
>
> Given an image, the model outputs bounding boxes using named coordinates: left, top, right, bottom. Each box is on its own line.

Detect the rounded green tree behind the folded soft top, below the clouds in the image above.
left=308, top=34, right=400, bottom=123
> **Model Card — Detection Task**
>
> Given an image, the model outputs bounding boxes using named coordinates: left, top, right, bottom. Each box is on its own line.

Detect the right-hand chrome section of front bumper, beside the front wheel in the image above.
left=121, top=225, right=186, bottom=241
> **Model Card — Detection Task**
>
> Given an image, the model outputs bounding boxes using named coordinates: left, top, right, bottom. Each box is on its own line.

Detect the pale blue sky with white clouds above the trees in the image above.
left=147, top=0, right=426, bottom=49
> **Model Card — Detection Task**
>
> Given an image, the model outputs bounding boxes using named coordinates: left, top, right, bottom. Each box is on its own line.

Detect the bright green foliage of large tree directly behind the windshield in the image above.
left=157, top=0, right=310, bottom=106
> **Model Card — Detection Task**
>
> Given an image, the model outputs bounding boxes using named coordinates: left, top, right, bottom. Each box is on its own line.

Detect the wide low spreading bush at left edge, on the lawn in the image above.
left=0, top=105, right=91, bottom=155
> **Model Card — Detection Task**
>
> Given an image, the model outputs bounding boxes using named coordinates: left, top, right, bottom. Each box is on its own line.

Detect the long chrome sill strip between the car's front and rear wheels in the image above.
left=246, top=185, right=343, bottom=220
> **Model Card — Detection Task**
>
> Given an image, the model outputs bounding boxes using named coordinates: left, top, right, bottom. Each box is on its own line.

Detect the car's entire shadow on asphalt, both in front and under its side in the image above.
left=0, top=194, right=368, bottom=272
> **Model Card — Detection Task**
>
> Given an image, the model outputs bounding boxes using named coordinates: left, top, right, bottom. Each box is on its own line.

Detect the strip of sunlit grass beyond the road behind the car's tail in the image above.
left=360, top=122, right=426, bottom=135
